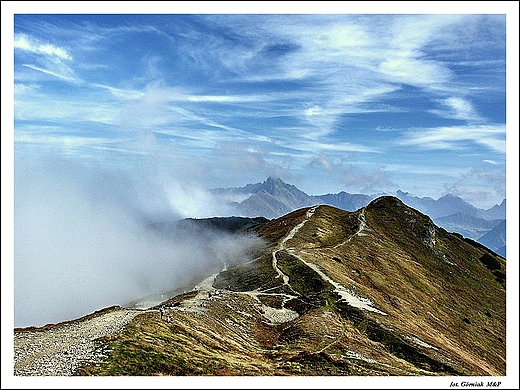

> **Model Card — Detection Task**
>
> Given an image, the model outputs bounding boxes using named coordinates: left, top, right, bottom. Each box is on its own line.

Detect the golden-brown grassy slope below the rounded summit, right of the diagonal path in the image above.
left=292, top=200, right=505, bottom=375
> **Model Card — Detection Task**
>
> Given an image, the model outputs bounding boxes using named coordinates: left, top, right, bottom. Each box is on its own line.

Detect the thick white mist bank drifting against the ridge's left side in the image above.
left=14, top=158, right=258, bottom=327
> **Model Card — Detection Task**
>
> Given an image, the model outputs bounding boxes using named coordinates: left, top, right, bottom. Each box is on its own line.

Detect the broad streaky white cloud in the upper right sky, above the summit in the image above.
left=206, top=15, right=479, bottom=146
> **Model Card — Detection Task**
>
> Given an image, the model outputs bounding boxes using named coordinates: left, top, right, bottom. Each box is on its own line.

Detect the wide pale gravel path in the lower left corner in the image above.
left=14, top=308, right=143, bottom=376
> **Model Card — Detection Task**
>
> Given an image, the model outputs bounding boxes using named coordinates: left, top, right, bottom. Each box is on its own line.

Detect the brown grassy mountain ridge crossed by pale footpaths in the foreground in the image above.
left=26, top=197, right=506, bottom=376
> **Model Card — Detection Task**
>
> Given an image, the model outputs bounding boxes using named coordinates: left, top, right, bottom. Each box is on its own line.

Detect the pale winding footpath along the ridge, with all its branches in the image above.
left=14, top=206, right=386, bottom=376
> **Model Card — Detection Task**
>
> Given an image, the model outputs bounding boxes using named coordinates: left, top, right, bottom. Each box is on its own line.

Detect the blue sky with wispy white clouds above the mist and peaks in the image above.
left=7, top=5, right=516, bottom=208
